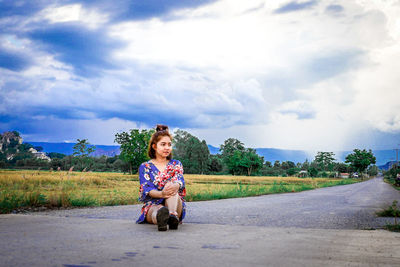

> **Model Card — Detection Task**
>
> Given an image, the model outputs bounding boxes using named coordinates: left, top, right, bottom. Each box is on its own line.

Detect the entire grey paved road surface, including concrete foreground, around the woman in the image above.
left=0, top=178, right=400, bottom=266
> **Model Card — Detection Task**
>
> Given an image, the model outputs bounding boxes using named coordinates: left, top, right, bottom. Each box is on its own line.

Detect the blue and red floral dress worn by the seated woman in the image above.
left=136, top=159, right=186, bottom=223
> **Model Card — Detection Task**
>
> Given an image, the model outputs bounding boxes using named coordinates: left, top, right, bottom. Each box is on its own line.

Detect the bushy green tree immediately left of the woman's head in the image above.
left=114, top=129, right=154, bottom=174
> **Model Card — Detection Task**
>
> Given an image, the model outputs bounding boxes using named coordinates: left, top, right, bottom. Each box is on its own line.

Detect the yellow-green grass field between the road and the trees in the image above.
left=0, top=170, right=358, bottom=213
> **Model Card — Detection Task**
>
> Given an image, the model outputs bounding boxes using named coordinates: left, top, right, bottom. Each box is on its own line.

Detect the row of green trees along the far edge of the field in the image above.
left=0, top=129, right=379, bottom=177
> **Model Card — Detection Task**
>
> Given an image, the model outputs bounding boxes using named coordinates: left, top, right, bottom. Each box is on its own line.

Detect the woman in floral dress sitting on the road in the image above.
left=136, top=125, right=186, bottom=231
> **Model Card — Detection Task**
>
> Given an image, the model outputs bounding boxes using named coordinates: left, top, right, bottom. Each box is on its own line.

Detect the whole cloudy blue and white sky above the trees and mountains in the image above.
left=0, top=0, right=400, bottom=150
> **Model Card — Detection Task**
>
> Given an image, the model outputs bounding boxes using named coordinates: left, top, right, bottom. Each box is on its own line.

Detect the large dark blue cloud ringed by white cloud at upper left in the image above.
left=29, top=24, right=122, bottom=77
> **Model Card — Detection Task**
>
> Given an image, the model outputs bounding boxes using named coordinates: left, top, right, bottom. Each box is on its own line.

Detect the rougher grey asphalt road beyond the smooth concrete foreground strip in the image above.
left=28, top=177, right=400, bottom=229
